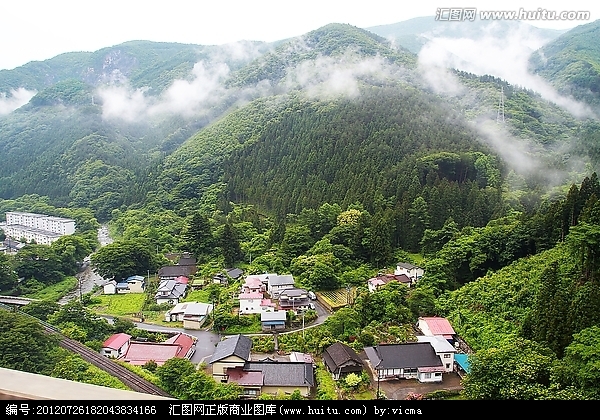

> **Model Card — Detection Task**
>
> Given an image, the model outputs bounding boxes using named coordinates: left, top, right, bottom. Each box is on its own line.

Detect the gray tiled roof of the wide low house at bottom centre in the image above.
left=244, top=362, right=315, bottom=387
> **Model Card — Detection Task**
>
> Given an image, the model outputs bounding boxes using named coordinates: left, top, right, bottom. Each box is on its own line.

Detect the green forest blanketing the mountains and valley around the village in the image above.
left=0, top=23, right=600, bottom=400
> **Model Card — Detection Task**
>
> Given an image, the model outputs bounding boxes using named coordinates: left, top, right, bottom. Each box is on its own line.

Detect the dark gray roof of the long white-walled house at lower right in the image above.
left=365, top=343, right=443, bottom=369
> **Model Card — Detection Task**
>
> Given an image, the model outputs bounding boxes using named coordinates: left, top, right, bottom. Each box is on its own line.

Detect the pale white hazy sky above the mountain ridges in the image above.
left=0, top=0, right=600, bottom=69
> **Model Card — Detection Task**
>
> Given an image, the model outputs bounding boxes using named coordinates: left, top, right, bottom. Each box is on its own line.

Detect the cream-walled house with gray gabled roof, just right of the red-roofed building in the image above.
left=208, top=334, right=252, bottom=383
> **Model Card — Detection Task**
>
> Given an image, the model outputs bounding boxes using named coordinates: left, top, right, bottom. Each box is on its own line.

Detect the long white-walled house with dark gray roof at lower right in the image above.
left=365, top=342, right=445, bottom=382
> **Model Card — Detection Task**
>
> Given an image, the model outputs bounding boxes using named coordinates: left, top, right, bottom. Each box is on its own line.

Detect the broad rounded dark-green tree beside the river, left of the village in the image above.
left=90, top=240, right=163, bottom=281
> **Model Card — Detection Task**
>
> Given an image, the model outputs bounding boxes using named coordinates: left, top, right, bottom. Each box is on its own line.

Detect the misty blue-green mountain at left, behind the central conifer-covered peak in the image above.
left=0, top=41, right=271, bottom=219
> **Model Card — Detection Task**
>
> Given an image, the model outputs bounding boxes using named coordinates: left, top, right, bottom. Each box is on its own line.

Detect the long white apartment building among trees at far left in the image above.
left=2, top=211, right=75, bottom=245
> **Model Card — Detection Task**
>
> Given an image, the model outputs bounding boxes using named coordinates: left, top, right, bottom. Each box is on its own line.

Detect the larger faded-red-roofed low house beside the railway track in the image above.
left=118, top=333, right=196, bottom=366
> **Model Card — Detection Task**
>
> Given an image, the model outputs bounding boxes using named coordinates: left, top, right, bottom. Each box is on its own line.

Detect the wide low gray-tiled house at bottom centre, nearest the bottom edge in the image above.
left=227, top=361, right=315, bottom=397
